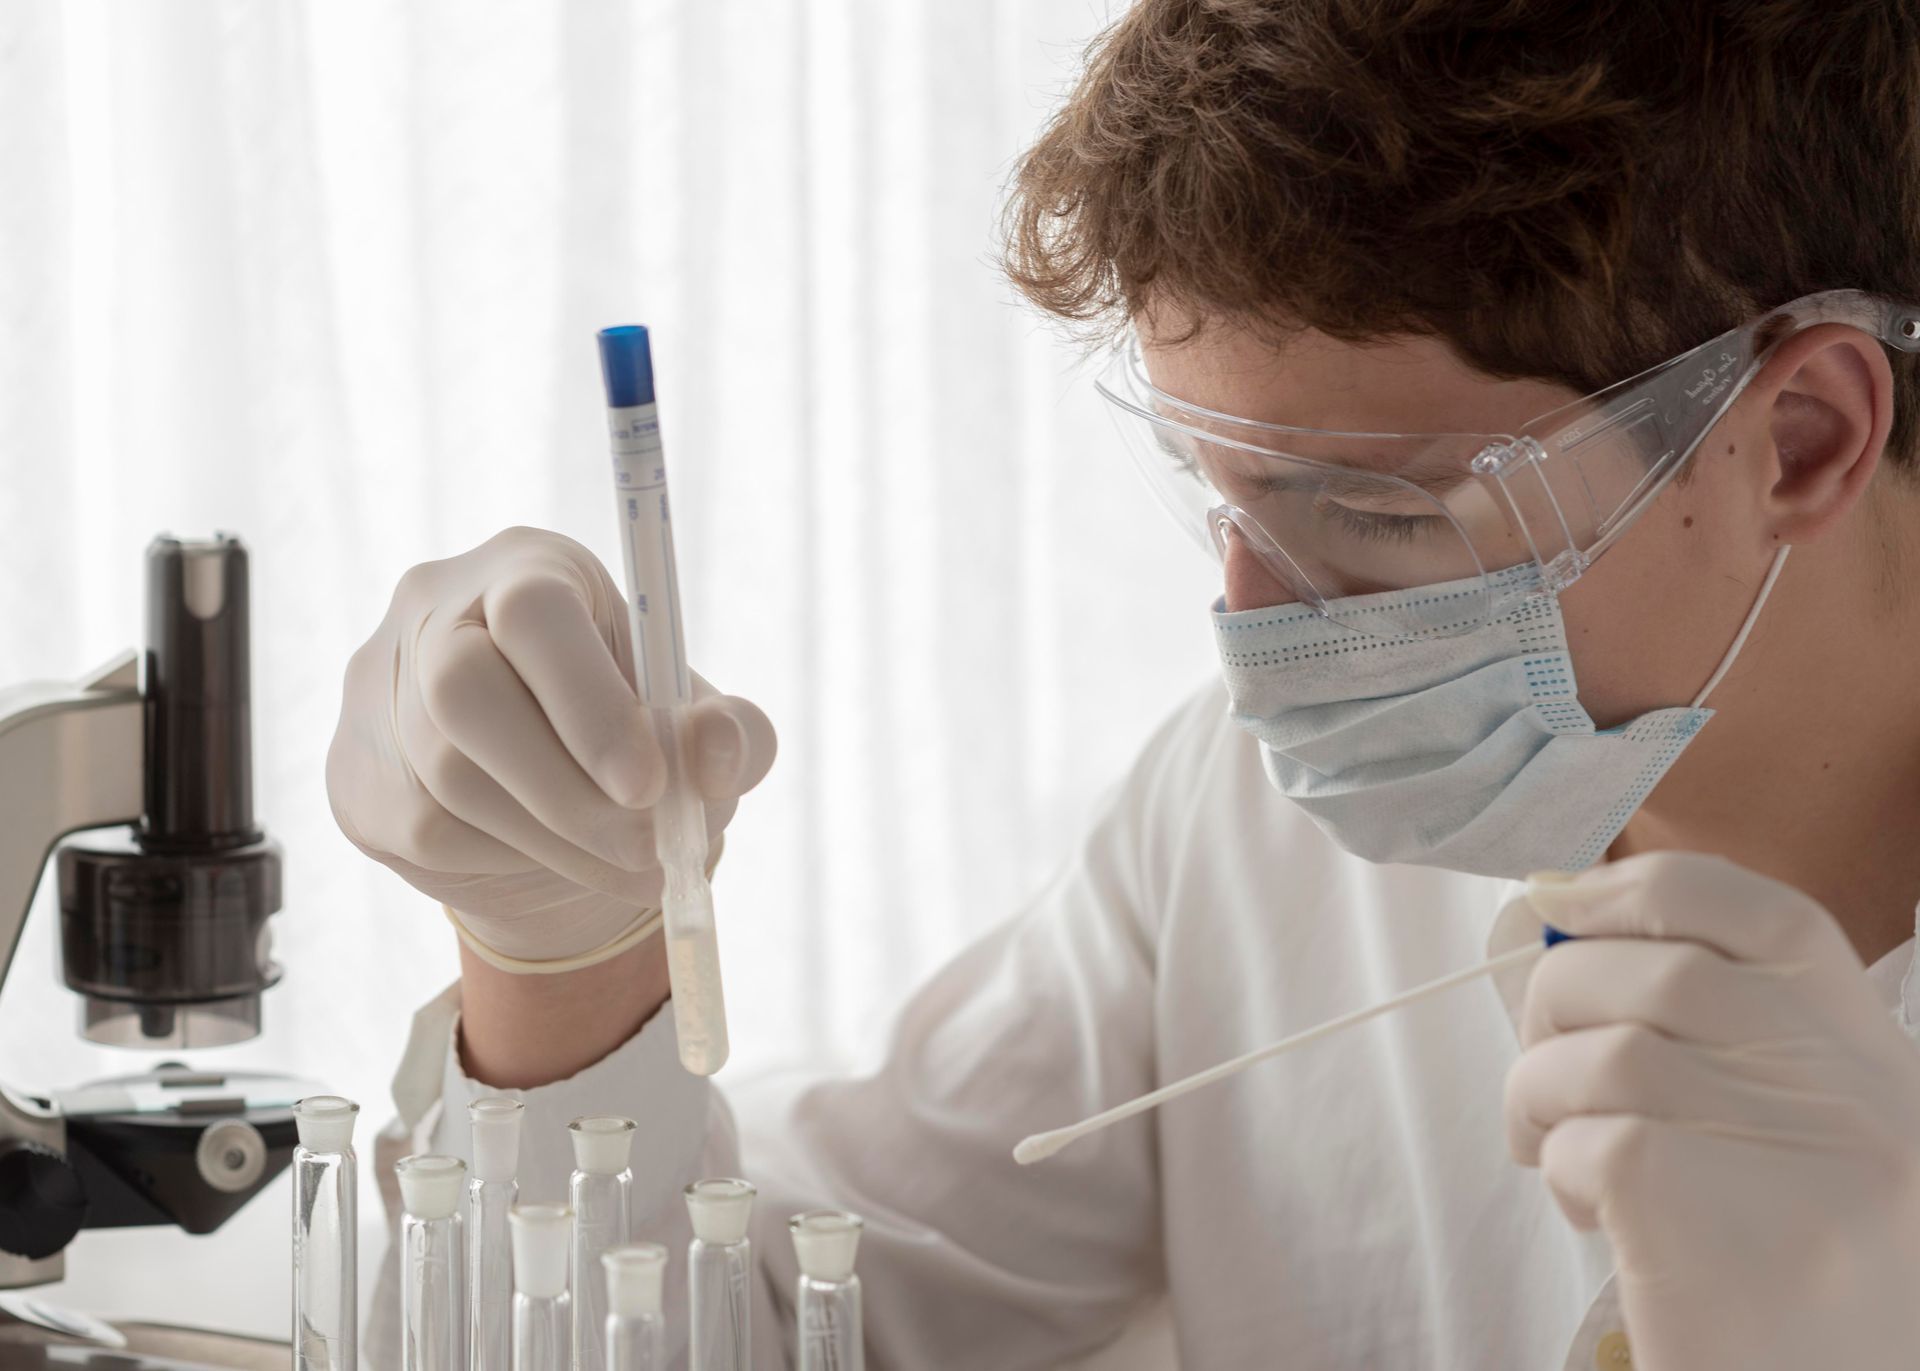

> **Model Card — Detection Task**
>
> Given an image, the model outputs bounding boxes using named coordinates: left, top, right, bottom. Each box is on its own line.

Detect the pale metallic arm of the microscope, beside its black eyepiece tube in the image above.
left=0, top=651, right=142, bottom=983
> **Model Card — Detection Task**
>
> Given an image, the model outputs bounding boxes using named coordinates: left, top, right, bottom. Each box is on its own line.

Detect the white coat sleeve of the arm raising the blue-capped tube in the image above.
left=369, top=695, right=1196, bottom=1371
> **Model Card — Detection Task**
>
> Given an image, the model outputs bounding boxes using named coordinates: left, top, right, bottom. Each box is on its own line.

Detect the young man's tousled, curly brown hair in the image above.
left=1002, top=0, right=1920, bottom=465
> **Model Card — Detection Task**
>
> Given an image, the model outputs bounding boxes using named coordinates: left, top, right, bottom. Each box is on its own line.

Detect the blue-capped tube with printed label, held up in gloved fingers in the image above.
left=599, top=325, right=728, bottom=1075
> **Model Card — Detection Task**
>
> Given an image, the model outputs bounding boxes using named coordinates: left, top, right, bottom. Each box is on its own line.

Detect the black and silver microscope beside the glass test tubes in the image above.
left=0, top=534, right=317, bottom=1313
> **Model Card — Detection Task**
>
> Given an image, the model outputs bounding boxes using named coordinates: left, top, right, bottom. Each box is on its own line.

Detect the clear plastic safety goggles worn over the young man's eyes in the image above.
left=1096, top=290, right=1920, bottom=637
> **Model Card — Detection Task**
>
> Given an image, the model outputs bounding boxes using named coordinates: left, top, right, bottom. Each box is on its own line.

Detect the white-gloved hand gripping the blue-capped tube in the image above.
left=326, top=528, right=774, bottom=962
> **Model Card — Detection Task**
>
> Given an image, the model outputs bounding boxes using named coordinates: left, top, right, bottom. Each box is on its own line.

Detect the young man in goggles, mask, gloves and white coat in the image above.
left=328, top=0, right=1920, bottom=1371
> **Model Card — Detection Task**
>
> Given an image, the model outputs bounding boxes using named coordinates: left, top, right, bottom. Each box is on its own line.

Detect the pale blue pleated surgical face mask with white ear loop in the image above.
left=1213, top=547, right=1788, bottom=878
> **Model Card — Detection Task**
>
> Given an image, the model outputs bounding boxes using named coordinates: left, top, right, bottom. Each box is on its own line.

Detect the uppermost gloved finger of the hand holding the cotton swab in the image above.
left=1526, top=853, right=1860, bottom=970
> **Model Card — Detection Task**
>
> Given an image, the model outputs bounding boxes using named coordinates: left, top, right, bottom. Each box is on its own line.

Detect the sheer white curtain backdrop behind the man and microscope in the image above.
left=0, top=0, right=1215, bottom=1333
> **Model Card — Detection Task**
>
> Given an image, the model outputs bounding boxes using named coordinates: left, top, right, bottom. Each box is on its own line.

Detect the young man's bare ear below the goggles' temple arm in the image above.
left=1749, top=325, right=1893, bottom=545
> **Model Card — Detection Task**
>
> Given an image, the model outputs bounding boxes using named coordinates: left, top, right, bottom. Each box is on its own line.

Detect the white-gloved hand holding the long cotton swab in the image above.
left=1507, top=853, right=1920, bottom=1371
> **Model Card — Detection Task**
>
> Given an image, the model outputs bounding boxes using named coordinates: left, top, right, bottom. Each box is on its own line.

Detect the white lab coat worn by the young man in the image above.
left=369, top=687, right=1912, bottom=1371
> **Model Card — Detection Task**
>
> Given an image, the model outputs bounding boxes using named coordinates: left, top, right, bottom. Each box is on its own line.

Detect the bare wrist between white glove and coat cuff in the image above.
left=459, top=937, right=668, bottom=1089
